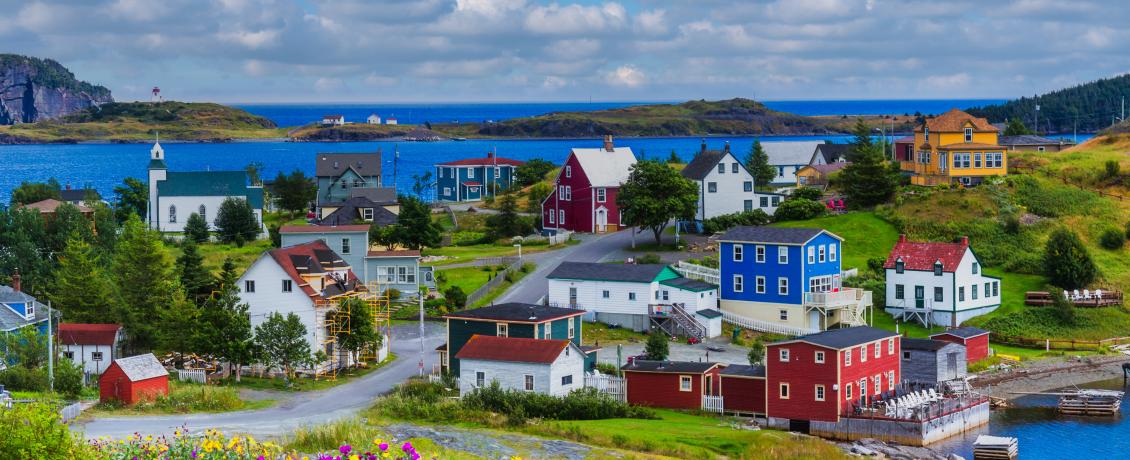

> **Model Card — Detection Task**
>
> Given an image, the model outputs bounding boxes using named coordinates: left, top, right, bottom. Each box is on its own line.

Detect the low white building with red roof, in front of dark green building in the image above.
left=455, top=335, right=584, bottom=396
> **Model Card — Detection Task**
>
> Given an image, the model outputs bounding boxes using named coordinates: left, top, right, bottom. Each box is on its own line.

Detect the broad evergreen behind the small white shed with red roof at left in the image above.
left=50, top=236, right=114, bottom=323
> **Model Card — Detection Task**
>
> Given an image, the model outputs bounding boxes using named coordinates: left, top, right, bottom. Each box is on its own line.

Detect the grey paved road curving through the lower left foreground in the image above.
left=71, top=323, right=446, bottom=439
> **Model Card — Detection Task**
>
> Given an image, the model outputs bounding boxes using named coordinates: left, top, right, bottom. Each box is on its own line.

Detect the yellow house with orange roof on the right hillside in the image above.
left=898, top=109, right=1008, bottom=185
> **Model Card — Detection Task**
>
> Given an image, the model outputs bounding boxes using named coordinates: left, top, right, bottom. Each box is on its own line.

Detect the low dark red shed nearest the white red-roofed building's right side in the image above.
left=620, top=359, right=722, bottom=409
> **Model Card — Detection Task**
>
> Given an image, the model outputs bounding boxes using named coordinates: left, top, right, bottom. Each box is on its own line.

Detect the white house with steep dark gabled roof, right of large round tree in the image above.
left=683, top=141, right=783, bottom=222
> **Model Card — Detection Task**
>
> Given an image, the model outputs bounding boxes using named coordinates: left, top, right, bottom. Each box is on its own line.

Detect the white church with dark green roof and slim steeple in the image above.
left=146, top=141, right=266, bottom=234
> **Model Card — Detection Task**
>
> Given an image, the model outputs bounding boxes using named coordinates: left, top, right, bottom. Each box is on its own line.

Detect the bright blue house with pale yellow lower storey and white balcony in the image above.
left=719, top=227, right=871, bottom=335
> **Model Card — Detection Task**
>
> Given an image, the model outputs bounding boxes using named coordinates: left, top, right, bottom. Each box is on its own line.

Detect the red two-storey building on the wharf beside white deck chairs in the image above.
left=768, top=327, right=901, bottom=433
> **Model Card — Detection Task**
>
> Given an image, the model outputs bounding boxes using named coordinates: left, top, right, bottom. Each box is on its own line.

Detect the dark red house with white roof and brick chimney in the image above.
left=541, top=136, right=636, bottom=233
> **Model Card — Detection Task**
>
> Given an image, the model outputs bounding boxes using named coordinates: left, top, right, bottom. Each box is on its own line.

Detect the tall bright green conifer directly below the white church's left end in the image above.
left=111, top=216, right=180, bottom=351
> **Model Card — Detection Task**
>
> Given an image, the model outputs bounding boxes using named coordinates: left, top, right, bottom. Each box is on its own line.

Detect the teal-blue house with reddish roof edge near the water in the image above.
left=435, top=153, right=523, bottom=201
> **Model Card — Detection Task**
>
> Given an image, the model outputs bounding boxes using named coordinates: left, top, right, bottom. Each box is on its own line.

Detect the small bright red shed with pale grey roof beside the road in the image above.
left=98, top=353, right=168, bottom=405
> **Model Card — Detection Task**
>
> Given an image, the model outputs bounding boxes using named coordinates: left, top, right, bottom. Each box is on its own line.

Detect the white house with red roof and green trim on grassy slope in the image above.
left=884, top=235, right=1000, bottom=327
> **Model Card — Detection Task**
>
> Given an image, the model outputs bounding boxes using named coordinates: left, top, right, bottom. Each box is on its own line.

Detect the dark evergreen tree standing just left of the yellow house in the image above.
left=840, top=119, right=898, bottom=207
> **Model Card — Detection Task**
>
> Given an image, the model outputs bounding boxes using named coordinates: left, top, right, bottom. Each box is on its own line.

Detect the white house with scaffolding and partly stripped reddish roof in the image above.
left=238, top=240, right=365, bottom=367
